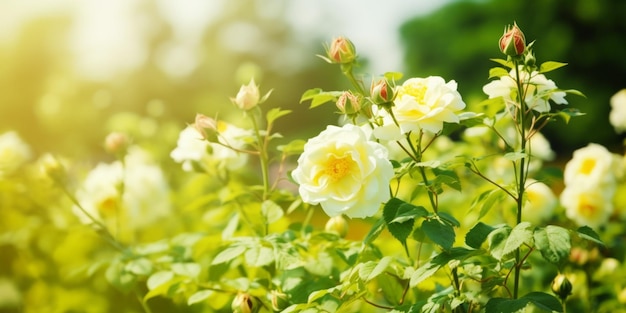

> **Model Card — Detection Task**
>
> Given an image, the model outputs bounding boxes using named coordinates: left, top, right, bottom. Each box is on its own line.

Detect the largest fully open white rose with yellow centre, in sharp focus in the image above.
left=292, top=124, right=394, bottom=218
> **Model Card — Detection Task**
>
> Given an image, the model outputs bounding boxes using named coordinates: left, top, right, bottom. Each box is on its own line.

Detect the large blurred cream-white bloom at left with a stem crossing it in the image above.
left=73, top=147, right=170, bottom=229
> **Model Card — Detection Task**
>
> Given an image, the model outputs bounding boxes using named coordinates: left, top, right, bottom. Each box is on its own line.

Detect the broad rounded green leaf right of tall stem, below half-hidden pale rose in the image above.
left=534, top=225, right=572, bottom=264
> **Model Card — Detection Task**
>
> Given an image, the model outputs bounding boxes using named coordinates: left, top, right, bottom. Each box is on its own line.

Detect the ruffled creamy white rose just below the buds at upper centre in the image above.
left=391, top=76, right=465, bottom=134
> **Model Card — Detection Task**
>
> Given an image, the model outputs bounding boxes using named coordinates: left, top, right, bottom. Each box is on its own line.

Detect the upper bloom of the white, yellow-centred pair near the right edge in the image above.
left=563, top=143, right=623, bottom=188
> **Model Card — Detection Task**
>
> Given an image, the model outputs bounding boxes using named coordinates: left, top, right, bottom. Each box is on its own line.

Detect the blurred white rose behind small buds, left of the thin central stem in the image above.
left=170, top=121, right=251, bottom=172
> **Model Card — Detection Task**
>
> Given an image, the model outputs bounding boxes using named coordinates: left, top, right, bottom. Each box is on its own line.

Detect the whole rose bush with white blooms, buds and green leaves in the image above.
left=0, top=25, right=626, bottom=313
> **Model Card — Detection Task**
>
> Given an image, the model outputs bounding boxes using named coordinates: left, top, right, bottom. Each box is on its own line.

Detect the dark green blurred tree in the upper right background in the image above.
left=401, top=0, right=626, bottom=157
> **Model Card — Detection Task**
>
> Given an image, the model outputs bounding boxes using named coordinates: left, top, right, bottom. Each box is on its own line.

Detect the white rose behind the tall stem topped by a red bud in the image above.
left=483, top=67, right=567, bottom=113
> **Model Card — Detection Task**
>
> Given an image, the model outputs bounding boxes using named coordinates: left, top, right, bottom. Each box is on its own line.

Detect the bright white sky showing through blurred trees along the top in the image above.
left=0, top=0, right=451, bottom=79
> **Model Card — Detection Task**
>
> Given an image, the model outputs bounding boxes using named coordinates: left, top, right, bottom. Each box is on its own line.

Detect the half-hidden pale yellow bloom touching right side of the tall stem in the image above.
left=523, top=179, right=558, bottom=225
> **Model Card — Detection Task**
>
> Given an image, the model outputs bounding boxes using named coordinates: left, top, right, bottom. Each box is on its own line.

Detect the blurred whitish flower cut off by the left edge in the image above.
left=0, top=131, right=32, bottom=178
